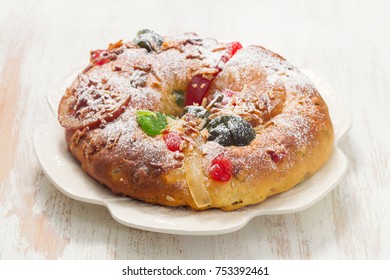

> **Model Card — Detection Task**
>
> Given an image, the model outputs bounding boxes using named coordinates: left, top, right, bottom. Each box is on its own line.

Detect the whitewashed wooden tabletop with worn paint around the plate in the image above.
left=0, top=0, right=390, bottom=259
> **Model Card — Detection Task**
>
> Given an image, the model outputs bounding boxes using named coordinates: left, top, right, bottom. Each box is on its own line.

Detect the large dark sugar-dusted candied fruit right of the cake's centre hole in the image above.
left=206, top=115, right=256, bottom=147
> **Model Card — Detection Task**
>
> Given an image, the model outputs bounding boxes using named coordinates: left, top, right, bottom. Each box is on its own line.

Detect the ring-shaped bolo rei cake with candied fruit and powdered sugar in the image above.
left=58, top=30, right=333, bottom=211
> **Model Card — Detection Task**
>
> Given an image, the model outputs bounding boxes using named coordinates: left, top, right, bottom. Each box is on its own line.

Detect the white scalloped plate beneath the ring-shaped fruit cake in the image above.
left=33, top=70, right=352, bottom=235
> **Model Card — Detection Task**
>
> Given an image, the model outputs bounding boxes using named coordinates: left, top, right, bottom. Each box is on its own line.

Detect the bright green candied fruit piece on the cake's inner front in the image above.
left=136, top=110, right=168, bottom=136
